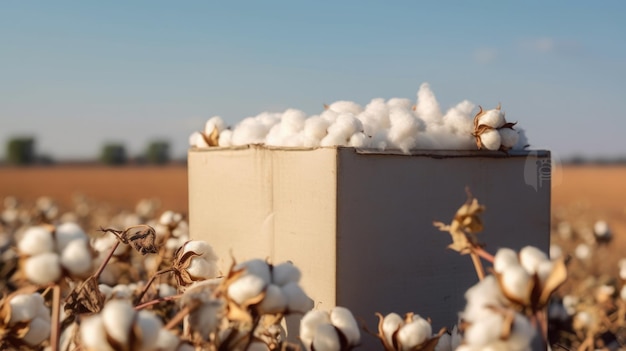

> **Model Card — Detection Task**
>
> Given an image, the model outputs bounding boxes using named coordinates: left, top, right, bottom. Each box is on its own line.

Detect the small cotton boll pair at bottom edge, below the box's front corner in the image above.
left=300, top=306, right=361, bottom=351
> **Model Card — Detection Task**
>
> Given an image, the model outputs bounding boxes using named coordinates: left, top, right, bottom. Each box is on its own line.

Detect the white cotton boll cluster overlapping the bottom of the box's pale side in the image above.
left=227, top=259, right=313, bottom=315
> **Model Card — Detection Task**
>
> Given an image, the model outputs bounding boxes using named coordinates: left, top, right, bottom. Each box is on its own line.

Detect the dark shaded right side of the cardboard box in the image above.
left=337, top=150, right=550, bottom=338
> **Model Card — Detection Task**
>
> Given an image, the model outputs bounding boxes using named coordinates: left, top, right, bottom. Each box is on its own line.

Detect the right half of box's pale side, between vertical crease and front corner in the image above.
left=272, top=149, right=337, bottom=306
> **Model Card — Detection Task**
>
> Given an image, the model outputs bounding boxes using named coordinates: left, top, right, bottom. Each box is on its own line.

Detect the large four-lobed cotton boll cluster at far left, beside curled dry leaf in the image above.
left=17, top=223, right=93, bottom=285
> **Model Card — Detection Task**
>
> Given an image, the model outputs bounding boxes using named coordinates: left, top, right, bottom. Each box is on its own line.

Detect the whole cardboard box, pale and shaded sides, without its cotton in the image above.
left=188, top=146, right=550, bottom=339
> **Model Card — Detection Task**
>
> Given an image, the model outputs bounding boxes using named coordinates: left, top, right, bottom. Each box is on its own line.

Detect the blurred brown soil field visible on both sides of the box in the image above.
left=0, top=165, right=626, bottom=220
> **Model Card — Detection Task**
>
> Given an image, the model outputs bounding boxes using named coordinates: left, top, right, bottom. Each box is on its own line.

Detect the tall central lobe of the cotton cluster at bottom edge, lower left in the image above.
left=100, top=300, right=136, bottom=345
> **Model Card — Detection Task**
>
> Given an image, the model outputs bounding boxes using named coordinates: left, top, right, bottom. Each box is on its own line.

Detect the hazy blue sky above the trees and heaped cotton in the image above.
left=0, top=0, right=626, bottom=159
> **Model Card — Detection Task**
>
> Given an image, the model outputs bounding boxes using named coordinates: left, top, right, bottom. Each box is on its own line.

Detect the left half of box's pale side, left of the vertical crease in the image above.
left=188, top=148, right=273, bottom=273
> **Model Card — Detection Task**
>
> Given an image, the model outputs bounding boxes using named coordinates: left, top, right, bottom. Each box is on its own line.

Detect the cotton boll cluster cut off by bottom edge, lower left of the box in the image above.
left=80, top=300, right=189, bottom=351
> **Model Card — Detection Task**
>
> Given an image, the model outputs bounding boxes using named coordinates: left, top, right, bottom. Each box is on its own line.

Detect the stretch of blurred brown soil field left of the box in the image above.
left=0, top=165, right=188, bottom=213
